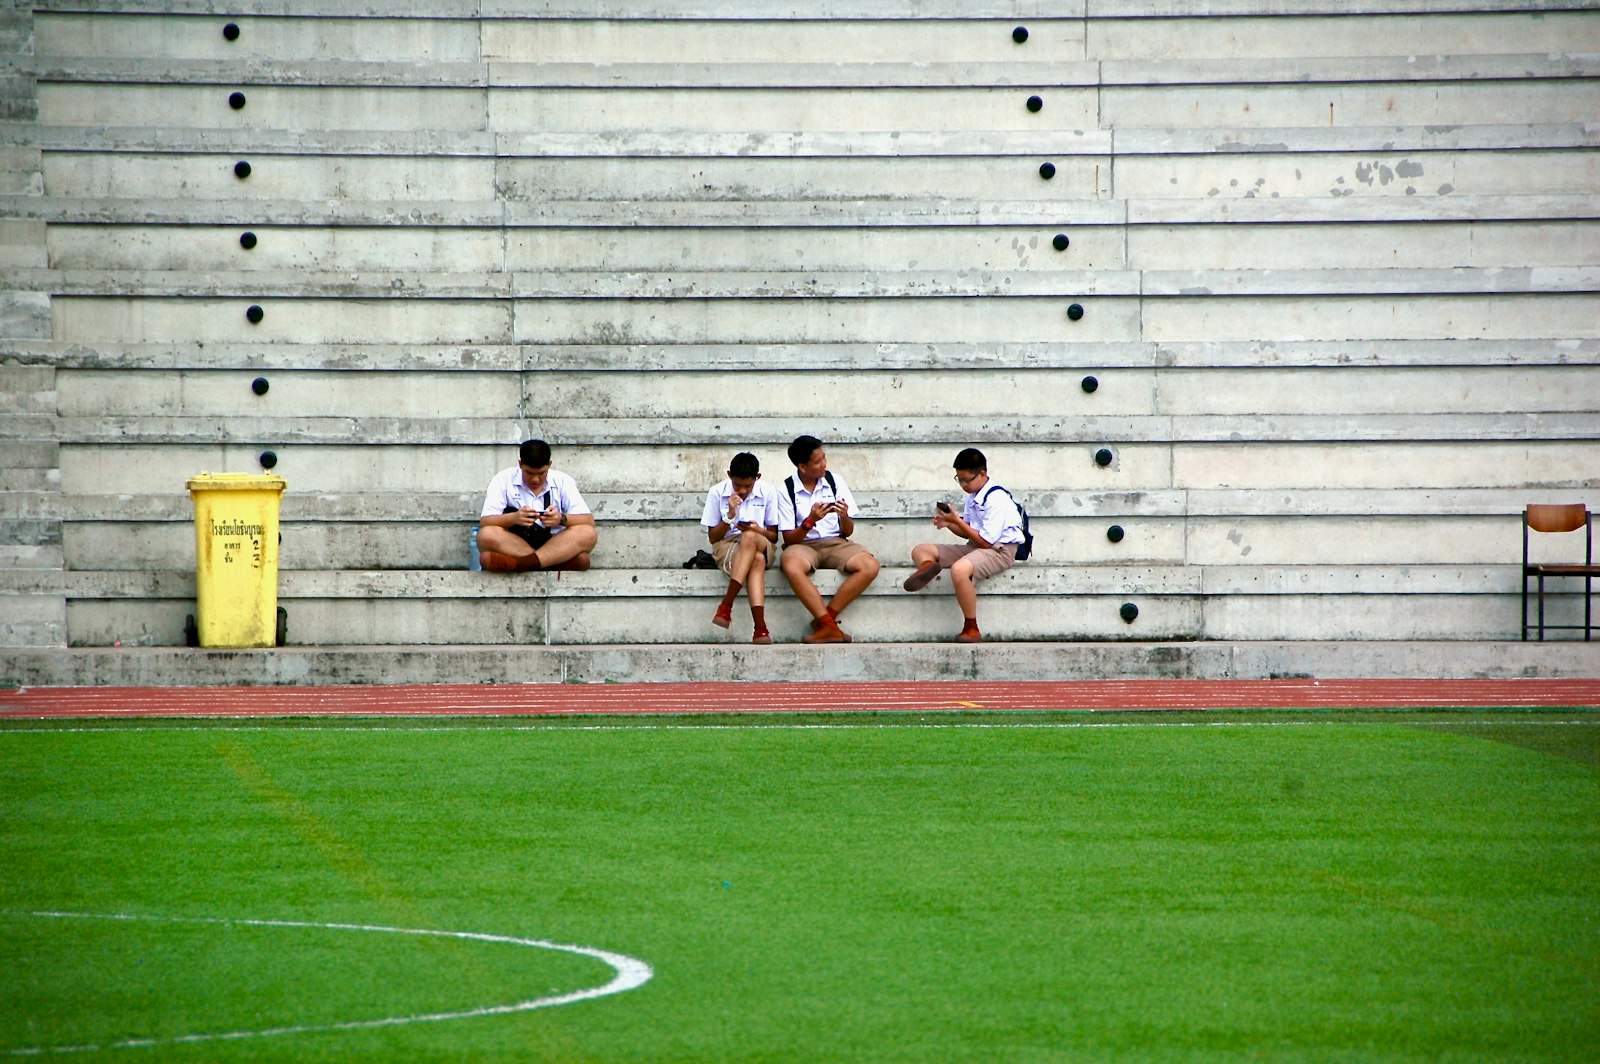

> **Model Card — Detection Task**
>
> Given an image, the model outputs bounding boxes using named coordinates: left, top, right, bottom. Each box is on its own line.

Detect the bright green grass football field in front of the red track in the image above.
left=0, top=710, right=1600, bottom=1062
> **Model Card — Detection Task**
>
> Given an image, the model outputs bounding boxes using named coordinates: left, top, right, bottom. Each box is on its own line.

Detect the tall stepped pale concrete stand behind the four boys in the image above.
left=0, top=0, right=1600, bottom=646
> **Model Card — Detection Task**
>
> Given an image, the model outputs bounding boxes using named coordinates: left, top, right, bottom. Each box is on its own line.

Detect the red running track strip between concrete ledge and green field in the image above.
left=0, top=678, right=1600, bottom=718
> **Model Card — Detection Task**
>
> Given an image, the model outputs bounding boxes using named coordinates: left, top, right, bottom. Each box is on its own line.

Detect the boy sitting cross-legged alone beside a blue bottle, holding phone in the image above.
left=478, top=440, right=598, bottom=573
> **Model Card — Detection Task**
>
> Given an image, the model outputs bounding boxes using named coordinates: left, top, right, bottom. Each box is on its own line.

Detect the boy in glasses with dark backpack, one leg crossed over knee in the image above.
left=902, top=446, right=1022, bottom=643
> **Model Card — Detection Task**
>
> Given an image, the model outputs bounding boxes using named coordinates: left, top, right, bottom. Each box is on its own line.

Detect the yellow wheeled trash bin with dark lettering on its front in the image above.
left=189, top=474, right=288, bottom=646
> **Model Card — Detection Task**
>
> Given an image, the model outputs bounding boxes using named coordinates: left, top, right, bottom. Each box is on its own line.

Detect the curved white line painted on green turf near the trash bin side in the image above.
left=6, top=912, right=656, bottom=1056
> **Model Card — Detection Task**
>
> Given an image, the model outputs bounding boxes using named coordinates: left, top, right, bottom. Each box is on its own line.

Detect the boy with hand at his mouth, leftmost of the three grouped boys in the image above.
left=701, top=451, right=778, bottom=643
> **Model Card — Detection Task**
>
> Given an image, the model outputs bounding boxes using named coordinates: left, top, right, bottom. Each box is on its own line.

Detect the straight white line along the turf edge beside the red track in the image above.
left=0, top=714, right=1600, bottom=736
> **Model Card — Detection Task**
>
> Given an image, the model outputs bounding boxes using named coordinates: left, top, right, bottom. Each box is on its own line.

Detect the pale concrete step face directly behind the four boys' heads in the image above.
left=50, top=438, right=1600, bottom=494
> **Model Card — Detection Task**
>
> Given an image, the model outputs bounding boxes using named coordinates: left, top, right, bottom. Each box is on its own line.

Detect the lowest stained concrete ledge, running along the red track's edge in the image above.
left=0, top=640, right=1594, bottom=686
